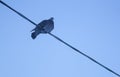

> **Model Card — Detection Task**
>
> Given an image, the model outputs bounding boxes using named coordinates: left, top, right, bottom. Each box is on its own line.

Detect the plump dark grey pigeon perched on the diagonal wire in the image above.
left=31, top=17, right=54, bottom=39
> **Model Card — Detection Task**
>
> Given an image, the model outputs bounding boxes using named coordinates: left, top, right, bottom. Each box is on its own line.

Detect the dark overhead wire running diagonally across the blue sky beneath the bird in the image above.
left=0, top=0, right=120, bottom=77
